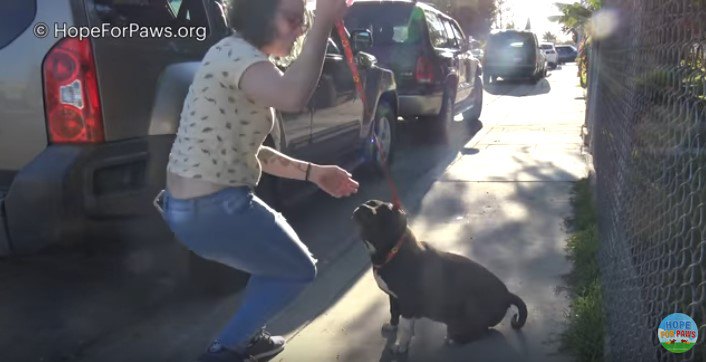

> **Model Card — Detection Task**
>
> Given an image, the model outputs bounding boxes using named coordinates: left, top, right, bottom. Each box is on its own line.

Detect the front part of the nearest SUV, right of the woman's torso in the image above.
left=256, top=25, right=398, bottom=208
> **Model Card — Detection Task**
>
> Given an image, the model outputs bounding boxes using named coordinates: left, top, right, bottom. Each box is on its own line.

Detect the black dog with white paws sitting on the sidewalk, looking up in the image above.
left=353, top=200, right=527, bottom=353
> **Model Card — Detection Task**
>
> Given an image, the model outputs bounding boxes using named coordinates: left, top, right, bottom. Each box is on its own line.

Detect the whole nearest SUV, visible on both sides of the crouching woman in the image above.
left=0, top=0, right=397, bottom=256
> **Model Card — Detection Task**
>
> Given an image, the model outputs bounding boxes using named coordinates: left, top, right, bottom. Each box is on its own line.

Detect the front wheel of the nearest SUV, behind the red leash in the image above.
left=369, top=100, right=397, bottom=174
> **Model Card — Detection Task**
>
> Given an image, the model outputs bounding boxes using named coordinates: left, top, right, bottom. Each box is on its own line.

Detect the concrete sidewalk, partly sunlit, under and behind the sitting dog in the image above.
left=269, top=66, right=587, bottom=362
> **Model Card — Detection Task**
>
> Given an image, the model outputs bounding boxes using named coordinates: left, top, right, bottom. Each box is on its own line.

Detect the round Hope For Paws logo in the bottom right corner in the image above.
left=658, top=313, right=699, bottom=353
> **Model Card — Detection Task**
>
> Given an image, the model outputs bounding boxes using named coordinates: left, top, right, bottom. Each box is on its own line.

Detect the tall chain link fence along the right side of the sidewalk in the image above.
left=587, top=0, right=706, bottom=361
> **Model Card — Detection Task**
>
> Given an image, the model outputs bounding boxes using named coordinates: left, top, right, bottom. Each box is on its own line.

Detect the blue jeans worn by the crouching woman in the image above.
left=162, top=187, right=316, bottom=351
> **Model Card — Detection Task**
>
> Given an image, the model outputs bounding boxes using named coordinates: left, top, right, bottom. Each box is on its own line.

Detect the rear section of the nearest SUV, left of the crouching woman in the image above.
left=0, top=0, right=229, bottom=256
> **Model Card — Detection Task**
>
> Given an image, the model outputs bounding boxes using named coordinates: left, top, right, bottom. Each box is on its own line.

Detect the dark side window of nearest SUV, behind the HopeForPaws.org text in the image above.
left=95, top=0, right=208, bottom=31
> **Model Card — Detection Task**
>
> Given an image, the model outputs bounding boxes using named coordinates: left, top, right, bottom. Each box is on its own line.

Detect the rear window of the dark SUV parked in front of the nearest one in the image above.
left=345, top=3, right=423, bottom=46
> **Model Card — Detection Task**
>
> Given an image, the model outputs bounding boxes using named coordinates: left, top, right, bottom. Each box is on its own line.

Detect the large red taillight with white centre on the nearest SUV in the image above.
left=42, top=38, right=104, bottom=143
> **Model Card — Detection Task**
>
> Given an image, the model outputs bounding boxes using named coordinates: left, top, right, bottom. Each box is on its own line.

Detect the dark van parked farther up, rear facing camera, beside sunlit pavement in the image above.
left=483, top=30, right=547, bottom=84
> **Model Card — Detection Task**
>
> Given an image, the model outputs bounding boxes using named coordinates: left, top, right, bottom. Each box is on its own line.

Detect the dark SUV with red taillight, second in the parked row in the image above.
left=345, top=0, right=483, bottom=139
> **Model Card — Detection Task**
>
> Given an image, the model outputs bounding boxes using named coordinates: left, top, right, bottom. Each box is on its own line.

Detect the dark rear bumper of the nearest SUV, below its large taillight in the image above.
left=0, top=136, right=173, bottom=255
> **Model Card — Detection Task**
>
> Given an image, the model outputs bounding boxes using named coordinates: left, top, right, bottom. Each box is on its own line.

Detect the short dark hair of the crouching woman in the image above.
left=227, top=0, right=280, bottom=48
